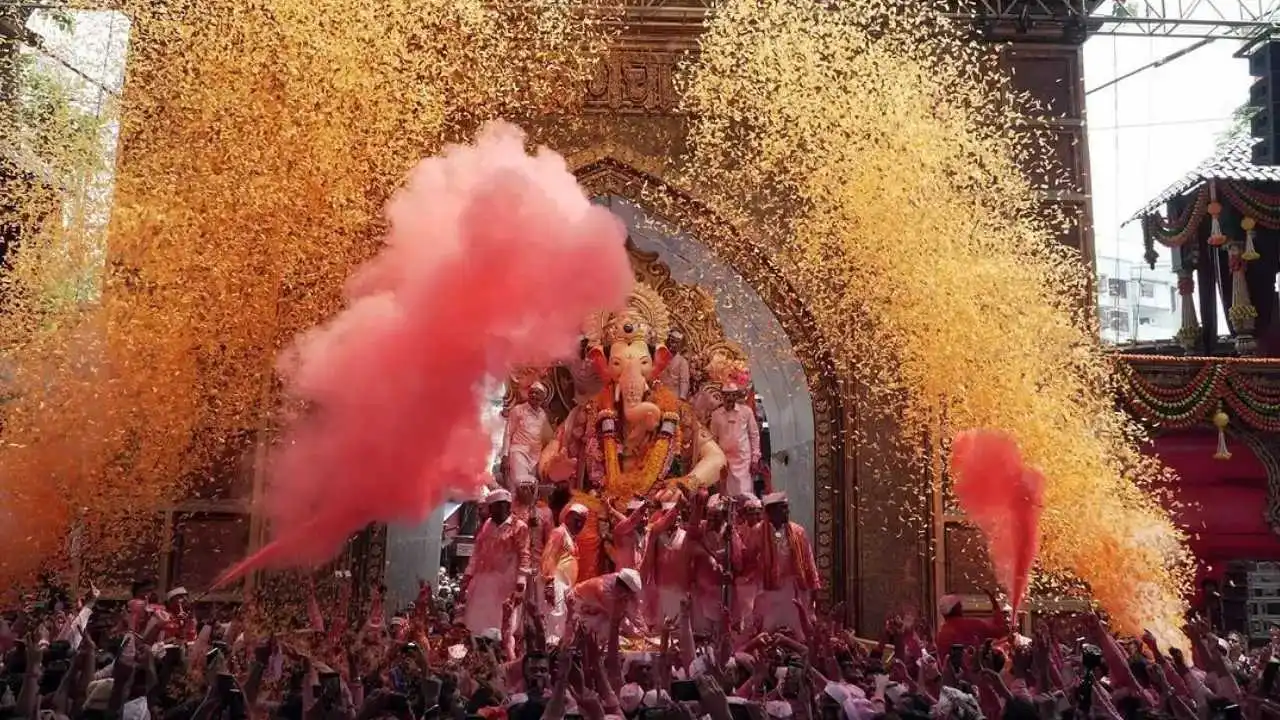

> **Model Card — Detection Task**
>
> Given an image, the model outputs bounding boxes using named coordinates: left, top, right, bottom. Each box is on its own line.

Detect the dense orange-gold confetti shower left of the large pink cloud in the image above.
left=0, top=0, right=607, bottom=584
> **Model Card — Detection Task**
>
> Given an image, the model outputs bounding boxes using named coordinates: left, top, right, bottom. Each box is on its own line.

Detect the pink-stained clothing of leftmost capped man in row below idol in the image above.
left=462, top=515, right=532, bottom=635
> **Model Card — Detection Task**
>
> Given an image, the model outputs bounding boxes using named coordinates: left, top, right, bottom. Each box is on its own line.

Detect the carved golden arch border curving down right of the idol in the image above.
left=570, top=156, right=858, bottom=603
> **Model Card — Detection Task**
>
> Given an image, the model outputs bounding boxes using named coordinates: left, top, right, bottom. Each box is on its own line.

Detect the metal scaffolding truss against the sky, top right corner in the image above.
left=947, top=0, right=1280, bottom=38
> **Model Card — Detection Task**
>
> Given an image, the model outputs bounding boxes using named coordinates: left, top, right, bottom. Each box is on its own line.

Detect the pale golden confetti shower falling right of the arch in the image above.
left=685, top=0, right=1184, bottom=639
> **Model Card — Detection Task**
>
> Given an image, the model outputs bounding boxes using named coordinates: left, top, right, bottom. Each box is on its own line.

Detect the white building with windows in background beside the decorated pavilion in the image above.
left=1097, top=256, right=1181, bottom=345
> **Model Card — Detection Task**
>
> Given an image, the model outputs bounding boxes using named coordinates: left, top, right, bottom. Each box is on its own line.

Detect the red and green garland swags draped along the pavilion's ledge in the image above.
left=1117, top=359, right=1280, bottom=432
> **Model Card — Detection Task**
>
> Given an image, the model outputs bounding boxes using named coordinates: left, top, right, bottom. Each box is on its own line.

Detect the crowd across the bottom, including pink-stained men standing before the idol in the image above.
left=0, top=481, right=1280, bottom=720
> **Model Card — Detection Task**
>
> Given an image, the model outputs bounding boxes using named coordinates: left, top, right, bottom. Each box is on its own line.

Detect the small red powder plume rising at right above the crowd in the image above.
left=951, top=430, right=1044, bottom=611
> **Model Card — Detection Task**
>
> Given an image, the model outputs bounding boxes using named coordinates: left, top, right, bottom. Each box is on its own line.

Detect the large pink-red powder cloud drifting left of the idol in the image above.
left=220, top=123, right=634, bottom=583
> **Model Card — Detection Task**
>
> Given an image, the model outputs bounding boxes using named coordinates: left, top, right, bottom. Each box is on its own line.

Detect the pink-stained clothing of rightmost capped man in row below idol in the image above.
left=744, top=521, right=819, bottom=637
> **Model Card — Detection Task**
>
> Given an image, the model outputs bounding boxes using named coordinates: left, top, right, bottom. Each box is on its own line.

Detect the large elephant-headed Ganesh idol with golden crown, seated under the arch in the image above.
left=539, top=283, right=724, bottom=582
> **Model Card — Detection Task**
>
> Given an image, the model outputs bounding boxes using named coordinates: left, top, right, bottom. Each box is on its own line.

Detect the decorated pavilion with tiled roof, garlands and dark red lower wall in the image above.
left=1131, top=136, right=1280, bottom=635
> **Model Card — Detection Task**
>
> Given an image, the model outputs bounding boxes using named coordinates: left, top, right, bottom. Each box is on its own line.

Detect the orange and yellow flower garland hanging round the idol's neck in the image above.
left=596, top=387, right=681, bottom=500
